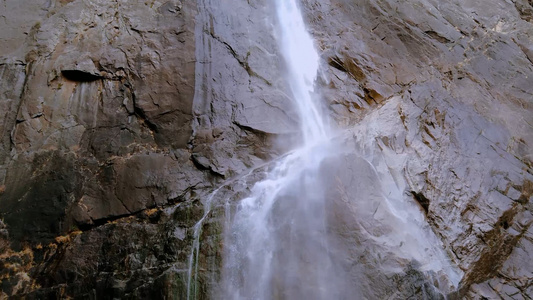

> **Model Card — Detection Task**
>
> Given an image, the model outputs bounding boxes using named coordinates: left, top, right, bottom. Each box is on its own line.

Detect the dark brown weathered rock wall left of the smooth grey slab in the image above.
left=0, top=1, right=212, bottom=298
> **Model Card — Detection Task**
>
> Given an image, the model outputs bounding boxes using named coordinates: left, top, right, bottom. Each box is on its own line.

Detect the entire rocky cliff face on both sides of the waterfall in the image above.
left=0, top=0, right=533, bottom=299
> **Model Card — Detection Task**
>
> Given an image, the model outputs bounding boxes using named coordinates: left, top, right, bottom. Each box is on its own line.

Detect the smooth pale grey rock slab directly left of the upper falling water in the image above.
left=192, top=0, right=297, bottom=177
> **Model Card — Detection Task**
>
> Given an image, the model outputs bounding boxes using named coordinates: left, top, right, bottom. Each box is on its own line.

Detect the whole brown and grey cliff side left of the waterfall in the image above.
left=0, top=1, right=286, bottom=298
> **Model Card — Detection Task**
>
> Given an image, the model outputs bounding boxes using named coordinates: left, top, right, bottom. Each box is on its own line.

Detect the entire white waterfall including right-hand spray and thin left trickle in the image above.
left=200, top=0, right=462, bottom=300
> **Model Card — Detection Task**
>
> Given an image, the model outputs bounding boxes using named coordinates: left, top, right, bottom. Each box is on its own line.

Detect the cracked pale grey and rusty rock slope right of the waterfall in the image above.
left=307, top=1, right=533, bottom=299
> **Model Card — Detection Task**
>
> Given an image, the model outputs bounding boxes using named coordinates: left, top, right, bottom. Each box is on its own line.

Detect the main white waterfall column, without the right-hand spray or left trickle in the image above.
left=222, top=0, right=341, bottom=299
